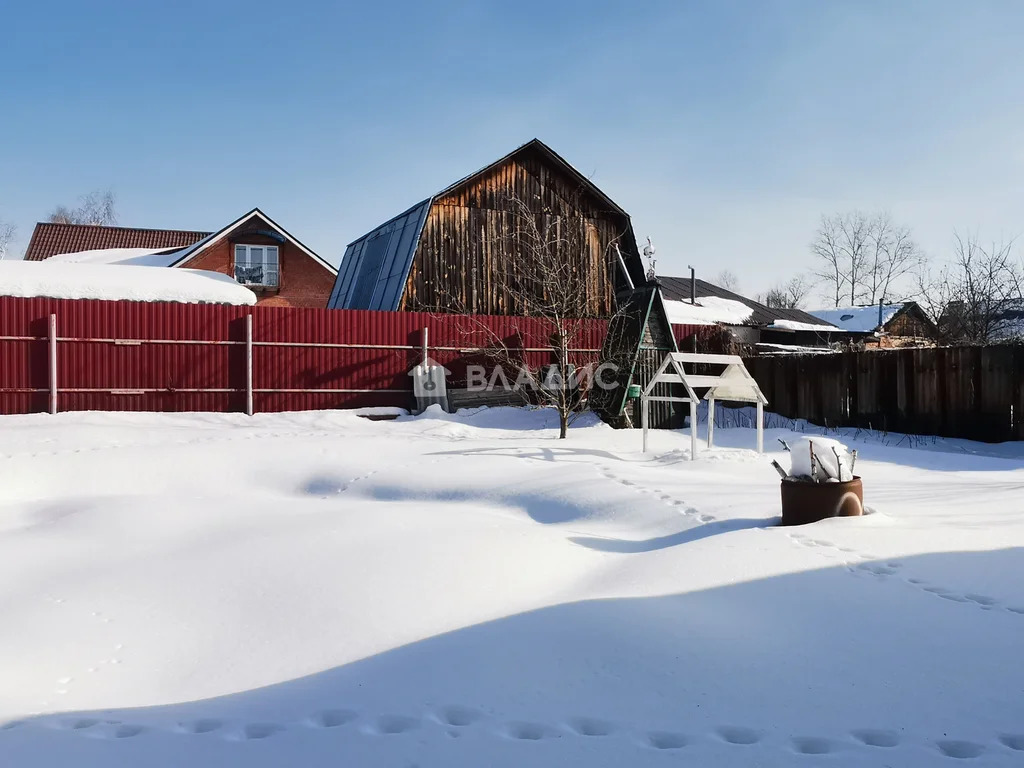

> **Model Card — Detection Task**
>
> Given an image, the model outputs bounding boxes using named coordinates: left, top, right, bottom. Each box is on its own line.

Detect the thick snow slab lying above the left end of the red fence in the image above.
left=0, top=261, right=256, bottom=305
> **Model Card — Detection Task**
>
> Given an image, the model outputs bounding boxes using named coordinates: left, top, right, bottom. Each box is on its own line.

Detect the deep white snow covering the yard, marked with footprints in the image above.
left=0, top=409, right=1024, bottom=768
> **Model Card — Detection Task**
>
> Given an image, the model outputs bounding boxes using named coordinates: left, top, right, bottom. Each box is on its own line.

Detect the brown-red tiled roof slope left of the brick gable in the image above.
left=25, top=221, right=210, bottom=261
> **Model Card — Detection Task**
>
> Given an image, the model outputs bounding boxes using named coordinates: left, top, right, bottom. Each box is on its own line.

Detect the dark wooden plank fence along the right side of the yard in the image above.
left=745, top=345, right=1024, bottom=442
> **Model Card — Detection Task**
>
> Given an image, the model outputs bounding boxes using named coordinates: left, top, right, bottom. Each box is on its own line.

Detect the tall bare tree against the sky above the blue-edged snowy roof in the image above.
left=811, top=211, right=922, bottom=306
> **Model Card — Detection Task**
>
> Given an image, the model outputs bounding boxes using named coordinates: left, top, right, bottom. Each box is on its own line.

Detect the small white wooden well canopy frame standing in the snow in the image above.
left=640, top=352, right=768, bottom=461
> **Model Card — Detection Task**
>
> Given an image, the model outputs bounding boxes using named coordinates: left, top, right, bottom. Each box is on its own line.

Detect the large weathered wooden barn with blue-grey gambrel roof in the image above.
left=328, top=139, right=644, bottom=317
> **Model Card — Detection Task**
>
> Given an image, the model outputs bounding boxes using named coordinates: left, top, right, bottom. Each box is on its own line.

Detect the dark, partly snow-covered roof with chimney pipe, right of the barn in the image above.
left=658, top=276, right=838, bottom=333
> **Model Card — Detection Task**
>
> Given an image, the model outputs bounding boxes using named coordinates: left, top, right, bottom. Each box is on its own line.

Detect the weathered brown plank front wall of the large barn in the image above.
left=399, top=147, right=640, bottom=317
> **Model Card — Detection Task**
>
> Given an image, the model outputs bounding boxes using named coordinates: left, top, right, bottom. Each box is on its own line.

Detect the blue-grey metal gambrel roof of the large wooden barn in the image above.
left=328, top=138, right=643, bottom=311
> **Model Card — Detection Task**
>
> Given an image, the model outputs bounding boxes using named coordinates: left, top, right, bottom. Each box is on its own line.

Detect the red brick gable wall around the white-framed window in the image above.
left=178, top=216, right=335, bottom=309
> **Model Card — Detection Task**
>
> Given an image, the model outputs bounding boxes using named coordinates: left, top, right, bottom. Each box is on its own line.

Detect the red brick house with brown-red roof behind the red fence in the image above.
left=25, top=208, right=338, bottom=308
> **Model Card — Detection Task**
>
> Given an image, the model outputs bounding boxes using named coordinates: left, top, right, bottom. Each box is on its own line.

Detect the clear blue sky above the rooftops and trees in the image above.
left=0, top=0, right=1024, bottom=293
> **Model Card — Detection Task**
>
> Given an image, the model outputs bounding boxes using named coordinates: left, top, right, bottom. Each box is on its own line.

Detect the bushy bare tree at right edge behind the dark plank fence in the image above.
left=916, top=232, right=1024, bottom=344
